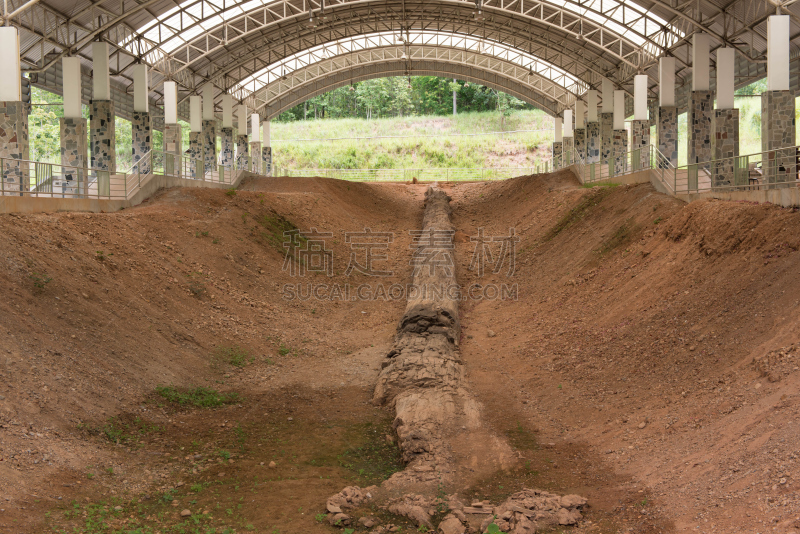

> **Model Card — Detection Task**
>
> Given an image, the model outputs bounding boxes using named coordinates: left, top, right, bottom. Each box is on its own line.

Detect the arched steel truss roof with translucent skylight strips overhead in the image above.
left=8, top=0, right=800, bottom=119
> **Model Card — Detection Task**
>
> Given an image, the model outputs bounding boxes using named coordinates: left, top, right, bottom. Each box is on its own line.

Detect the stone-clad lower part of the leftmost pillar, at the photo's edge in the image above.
left=0, top=101, right=30, bottom=194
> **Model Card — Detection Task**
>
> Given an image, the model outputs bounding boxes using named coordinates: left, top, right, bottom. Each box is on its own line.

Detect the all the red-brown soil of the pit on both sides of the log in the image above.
left=0, top=173, right=800, bottom=534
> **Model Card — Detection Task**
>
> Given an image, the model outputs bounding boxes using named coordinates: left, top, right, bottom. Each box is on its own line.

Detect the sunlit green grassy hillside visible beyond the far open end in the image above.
left=272, top=110, right=553, bottom=169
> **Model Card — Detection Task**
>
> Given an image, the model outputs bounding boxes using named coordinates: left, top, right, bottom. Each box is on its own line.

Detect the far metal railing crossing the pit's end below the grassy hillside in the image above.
left=273, top=162, right=550, bottom=182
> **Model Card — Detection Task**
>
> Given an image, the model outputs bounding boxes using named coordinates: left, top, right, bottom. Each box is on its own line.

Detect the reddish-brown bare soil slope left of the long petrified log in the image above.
left=0, top=179, right=424, bottom=532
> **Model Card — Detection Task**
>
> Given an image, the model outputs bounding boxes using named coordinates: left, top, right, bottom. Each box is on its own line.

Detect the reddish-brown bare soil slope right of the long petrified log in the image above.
left=450, top=173, right=800, bottom=532
